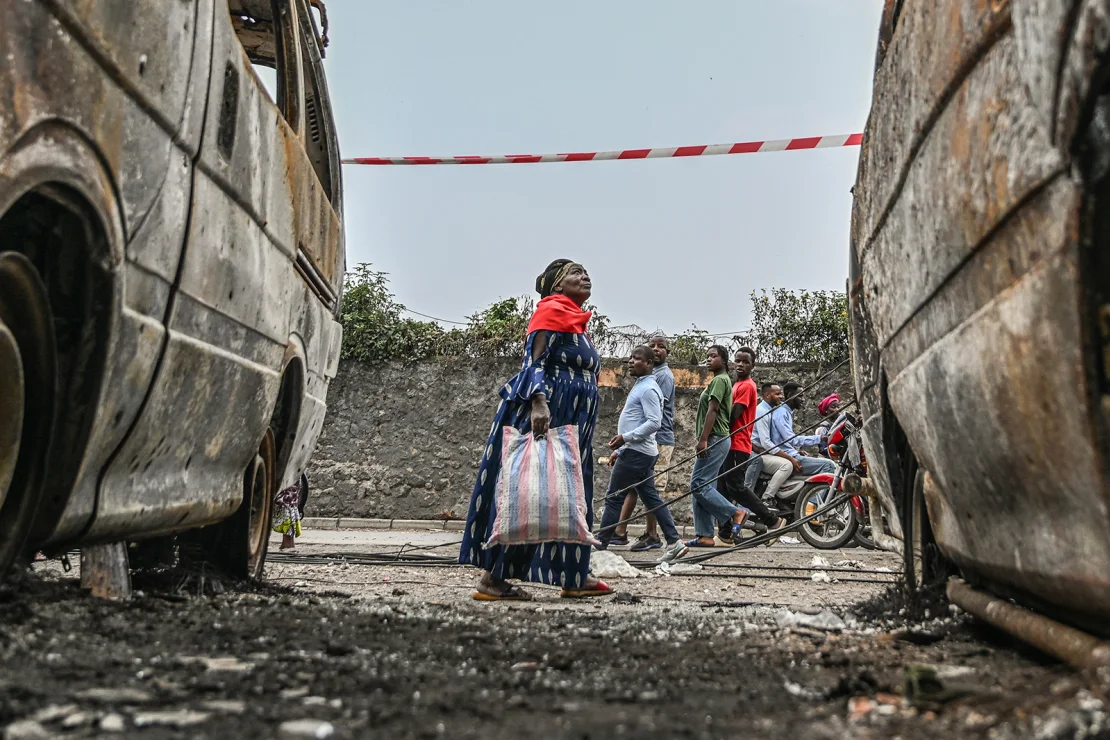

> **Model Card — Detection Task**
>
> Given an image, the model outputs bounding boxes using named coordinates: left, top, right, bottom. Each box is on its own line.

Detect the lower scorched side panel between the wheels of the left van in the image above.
left=89, top=169, right=290, bottom=538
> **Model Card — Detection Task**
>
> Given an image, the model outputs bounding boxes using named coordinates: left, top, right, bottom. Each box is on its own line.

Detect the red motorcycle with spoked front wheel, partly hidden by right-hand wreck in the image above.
left=794, top=414, right=875, bottom=550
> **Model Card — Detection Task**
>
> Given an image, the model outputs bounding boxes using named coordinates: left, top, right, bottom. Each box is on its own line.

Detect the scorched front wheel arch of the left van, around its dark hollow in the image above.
left=0, top=120, right=125, bottom=544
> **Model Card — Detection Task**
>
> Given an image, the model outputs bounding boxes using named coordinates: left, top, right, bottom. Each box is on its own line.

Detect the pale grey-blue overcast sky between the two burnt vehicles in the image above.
left=326, top=0, right=882, bottom=333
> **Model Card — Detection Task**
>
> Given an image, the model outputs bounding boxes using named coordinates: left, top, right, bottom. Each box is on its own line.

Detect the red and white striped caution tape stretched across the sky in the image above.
left=343, top=133, right=864, bottom=164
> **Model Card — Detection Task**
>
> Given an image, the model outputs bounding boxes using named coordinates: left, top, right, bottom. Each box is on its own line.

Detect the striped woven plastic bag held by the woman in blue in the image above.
left=485, top=425, right=598, bottom=548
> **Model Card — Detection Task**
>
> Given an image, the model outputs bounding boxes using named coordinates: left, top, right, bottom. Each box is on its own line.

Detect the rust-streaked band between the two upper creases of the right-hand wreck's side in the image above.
left=862, top=37, right=1063, bottom=345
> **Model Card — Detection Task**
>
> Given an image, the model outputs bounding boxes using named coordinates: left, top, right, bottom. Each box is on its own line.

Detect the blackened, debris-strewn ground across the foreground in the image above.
left=0, top=559, right=1110, bottom=739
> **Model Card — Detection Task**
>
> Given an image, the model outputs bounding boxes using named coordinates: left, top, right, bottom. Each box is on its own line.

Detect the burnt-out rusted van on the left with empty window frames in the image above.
left=0, top=0, right=345, bottom=575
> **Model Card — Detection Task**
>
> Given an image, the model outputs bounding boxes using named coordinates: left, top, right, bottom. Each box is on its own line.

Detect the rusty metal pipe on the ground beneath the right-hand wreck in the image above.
left=948, top=578, right=1110, bottom=670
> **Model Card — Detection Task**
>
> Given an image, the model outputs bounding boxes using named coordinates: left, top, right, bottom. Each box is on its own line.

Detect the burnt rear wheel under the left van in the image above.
left=199, top=428, right=278, bottom=579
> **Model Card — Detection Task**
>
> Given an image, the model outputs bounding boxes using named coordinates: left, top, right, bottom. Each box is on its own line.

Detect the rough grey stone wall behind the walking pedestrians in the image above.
left=306, top=358, right=850, bottom=520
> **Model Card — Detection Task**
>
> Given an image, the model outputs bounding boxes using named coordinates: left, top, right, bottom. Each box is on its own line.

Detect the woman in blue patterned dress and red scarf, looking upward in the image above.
left=458, top=260, right=612, bottom=601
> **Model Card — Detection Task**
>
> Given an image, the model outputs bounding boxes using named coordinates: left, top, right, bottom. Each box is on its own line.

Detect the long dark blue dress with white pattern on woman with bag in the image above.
left=458, top=331, right=601, bottom=588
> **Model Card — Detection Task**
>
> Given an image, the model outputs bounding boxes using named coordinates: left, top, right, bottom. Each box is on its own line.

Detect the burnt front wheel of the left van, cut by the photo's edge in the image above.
left=0, top=252, right=56, bottom=577
